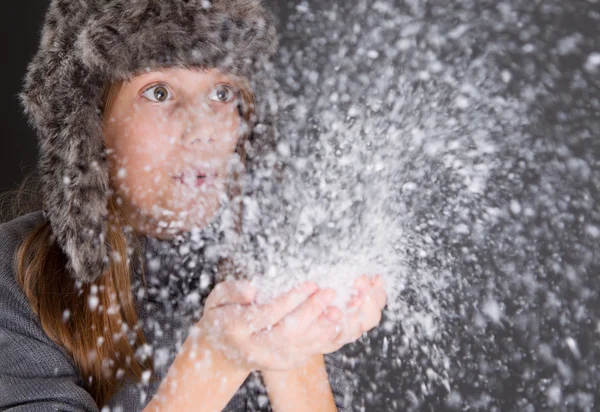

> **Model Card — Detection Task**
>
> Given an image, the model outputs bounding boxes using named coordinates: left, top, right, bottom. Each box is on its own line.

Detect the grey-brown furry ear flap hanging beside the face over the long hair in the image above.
left=20, top=51, right=110, bottom=282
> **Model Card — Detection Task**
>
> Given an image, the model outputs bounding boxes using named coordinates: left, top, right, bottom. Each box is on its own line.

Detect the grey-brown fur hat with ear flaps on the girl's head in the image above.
left=19, top=0, right=277, bottom=282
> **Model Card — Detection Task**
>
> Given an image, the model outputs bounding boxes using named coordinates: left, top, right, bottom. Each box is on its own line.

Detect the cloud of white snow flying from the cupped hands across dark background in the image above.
left=77, top=0, right=600, bottom=410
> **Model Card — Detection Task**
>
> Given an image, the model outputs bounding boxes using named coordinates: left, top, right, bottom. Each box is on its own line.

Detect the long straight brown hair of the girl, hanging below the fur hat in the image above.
left=0, top=70, right=254, bottom=407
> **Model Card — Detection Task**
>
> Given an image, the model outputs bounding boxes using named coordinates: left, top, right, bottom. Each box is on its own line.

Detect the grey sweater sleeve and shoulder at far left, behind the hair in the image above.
left=0, top=212, right=98, bottom=412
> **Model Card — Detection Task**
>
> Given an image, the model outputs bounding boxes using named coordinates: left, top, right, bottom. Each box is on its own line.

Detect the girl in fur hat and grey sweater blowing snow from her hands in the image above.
left=0, top=0, right=386, bottom=411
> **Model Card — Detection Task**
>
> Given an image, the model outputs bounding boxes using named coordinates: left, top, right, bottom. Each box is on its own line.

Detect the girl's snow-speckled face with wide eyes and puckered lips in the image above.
left=104, top=68, right=243, bottom=238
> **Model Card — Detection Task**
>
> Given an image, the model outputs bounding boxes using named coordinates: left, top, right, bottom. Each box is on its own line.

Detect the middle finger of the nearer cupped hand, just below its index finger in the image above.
left=272, top=289, right=336, bottom=340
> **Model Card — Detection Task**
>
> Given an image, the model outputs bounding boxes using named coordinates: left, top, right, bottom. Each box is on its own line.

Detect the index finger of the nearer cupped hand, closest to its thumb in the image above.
left=247, top=282, right=318, bottom=330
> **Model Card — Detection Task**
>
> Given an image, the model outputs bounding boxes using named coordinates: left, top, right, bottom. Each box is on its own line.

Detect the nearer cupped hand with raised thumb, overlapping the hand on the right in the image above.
left=197, top=280, right=344, bottom=371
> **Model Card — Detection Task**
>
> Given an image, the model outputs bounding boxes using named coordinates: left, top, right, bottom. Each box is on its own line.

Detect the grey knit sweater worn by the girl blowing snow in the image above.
left=0, top=211, right=352, bottom=412
